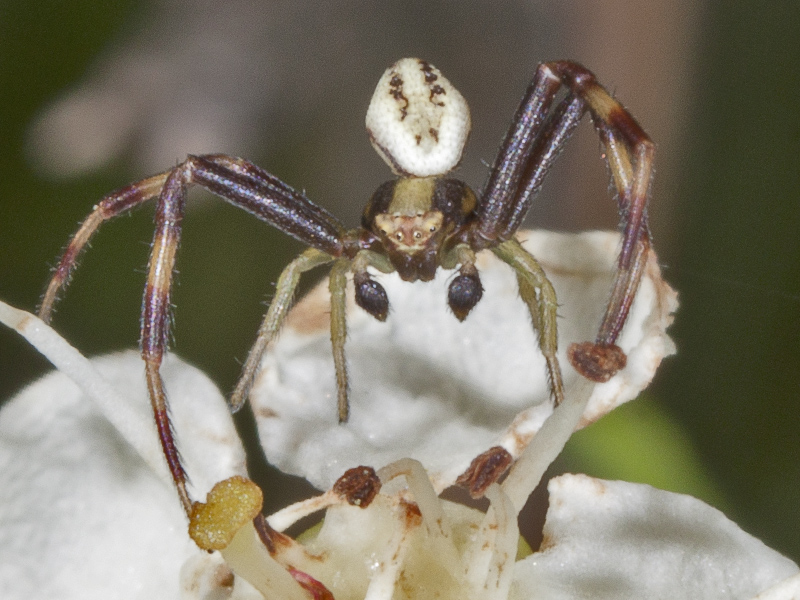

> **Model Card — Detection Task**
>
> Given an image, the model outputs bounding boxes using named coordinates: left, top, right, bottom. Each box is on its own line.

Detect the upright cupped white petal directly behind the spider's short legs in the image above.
left=251, top=232, right=676, bottom=490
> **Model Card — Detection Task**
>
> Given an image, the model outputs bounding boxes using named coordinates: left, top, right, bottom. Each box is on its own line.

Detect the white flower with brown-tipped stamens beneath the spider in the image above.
left=0, top=234, right=800, bottom=600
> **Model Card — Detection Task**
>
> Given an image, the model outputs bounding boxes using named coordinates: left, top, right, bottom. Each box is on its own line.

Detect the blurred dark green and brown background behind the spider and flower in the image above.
left=0, top=0, right=800, bottom=561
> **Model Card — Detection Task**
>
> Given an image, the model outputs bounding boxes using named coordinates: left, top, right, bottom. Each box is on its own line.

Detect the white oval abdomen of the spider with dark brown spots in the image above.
left=367, top=58, right=470, bottom=177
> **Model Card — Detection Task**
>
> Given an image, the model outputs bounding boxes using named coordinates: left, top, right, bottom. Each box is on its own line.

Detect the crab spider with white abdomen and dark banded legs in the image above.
left=39, top=58, right=654, bottom=514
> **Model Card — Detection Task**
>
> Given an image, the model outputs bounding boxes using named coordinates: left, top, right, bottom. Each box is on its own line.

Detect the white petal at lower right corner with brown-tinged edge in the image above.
left=510, top=475, right=798, bottom=600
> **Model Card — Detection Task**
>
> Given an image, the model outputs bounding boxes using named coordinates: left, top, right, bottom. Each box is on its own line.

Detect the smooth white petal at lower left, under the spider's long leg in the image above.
left=0, top=352, right=244, bottom=600
